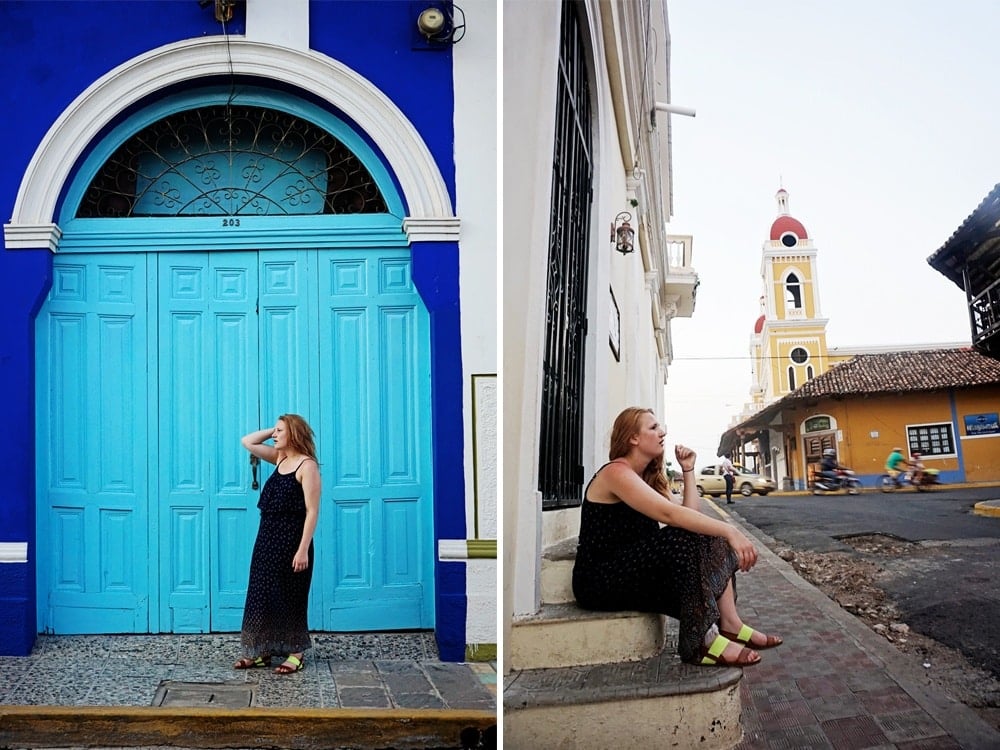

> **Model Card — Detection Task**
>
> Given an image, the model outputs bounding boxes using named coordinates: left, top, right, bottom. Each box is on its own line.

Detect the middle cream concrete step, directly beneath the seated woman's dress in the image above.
left=510, top=604, right=676, bottom=669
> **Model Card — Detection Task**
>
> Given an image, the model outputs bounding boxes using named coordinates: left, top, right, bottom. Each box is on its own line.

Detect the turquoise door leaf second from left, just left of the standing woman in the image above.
left=158, top=253, right=258, bottom=633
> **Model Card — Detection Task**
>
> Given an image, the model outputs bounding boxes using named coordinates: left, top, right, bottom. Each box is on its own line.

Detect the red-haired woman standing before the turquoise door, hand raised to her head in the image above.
left=233, top=414, right=320, bottom=674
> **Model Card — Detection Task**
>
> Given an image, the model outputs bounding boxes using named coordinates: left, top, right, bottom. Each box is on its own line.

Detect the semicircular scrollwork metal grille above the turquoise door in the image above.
left=76, top=104, right=388, bottom=218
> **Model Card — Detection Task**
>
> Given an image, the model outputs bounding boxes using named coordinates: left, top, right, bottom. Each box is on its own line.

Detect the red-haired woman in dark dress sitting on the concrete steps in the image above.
left=573, top=407, right=782, bottom=667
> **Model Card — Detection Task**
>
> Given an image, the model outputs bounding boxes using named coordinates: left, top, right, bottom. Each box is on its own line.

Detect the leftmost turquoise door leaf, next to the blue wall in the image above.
left=36, top=256, right=150, bottom=633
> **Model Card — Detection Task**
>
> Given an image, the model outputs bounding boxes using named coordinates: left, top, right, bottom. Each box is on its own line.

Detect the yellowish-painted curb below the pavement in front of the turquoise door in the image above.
left=0, top=706, right=497, bottom=750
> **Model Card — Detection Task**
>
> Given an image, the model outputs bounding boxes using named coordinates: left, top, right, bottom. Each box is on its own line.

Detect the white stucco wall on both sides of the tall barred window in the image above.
left=501, top=0, right=684, bottom=661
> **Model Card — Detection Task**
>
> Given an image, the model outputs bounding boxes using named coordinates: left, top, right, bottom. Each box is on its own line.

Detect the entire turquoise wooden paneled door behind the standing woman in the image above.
left=36, top=248, right=434, bottom=633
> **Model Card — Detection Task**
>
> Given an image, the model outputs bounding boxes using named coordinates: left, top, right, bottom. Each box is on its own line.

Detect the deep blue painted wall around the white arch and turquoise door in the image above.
left=0, top=0, right=466, bottom=659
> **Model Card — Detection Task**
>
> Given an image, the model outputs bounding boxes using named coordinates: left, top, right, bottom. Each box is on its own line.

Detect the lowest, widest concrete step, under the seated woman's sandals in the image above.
left=503, top=651, right=743, bottom=750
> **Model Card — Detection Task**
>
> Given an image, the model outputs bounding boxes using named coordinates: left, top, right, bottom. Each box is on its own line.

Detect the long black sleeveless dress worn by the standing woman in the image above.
left=240, top=459, right=313, bottom=657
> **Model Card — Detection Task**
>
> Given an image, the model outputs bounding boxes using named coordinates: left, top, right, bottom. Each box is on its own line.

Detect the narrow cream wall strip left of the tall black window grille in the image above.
left=501, top=2, right=562, bottom=636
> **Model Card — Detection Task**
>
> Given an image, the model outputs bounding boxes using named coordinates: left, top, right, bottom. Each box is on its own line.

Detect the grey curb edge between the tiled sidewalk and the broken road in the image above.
left=709, top=503, right=1000, bottom=748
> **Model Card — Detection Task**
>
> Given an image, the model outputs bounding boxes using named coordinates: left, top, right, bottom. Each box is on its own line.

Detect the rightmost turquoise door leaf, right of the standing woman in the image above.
left=319, top=252, right=433, bottom=630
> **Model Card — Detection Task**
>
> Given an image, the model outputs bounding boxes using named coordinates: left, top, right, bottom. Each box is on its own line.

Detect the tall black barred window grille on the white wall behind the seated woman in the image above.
left=539, top=0, right=593, bottom=509
